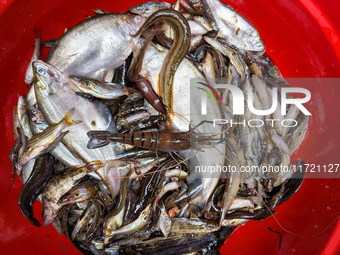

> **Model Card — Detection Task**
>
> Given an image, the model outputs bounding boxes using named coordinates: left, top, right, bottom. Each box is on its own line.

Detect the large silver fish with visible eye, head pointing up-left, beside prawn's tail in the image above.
left=33, top=61, right=123, bottom=180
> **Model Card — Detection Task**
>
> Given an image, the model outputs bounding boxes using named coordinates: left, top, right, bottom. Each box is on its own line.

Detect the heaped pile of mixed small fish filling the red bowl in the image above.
left=10, top=0, right=308, bottom=254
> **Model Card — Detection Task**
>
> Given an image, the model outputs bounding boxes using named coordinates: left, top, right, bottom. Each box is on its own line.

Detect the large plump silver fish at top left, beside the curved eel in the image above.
left=46, top=14, right=145, bottom=80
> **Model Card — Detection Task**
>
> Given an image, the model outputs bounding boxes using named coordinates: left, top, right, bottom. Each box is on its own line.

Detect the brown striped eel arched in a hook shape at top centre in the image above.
left=134, top=9, right=190, bottom=114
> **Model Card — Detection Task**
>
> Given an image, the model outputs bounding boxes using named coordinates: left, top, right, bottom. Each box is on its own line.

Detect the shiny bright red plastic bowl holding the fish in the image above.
left=0, top=0, right=340, bottom=255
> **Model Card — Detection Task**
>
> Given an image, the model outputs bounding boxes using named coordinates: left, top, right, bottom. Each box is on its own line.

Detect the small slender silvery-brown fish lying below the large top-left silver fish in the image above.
left=69, top=76, right=135, bottom=99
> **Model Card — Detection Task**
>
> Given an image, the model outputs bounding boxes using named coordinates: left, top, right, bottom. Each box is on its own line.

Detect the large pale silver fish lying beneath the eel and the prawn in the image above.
left=142, top=44, right=226, bottom=214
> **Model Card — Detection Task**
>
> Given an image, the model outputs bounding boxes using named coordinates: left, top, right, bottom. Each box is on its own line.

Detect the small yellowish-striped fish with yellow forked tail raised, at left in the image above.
left=17, top=108, right=81, bottom=172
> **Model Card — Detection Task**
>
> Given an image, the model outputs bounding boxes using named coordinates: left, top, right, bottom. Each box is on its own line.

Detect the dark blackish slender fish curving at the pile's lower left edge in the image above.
left=19, top=154, right=54, bottom=227
